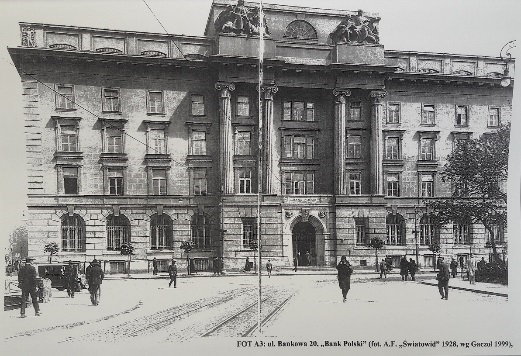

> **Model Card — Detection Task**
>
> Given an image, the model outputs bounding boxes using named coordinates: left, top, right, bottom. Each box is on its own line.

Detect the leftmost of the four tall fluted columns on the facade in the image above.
left=215, top=82, right=235, bottom=194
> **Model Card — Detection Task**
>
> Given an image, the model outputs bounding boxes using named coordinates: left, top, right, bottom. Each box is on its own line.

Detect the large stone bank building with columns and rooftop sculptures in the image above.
left=9, top=0, right=514, bottom=272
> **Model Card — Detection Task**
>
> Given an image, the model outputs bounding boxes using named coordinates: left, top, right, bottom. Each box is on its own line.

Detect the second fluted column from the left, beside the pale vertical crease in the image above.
left=262, top=85, right=279, bottom=194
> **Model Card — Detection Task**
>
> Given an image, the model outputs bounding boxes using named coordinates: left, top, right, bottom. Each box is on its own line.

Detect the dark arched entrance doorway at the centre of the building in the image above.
left=293, top=221, right=317, bottom=266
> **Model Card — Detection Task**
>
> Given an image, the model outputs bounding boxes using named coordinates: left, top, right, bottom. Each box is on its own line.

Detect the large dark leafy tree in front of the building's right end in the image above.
left=426, top=124, right=510, bottom=263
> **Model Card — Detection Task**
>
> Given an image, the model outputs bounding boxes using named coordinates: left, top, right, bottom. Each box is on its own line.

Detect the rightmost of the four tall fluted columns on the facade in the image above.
left=369, top=90, right=387, bottom=195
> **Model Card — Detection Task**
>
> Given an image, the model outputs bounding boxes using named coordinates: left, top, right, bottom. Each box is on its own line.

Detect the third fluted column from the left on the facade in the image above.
left=333, top=89, right=351, bottom=194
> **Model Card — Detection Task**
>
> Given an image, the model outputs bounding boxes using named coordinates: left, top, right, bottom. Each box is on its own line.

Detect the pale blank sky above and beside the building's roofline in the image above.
left=0, top=0, right=521, bottom=249
